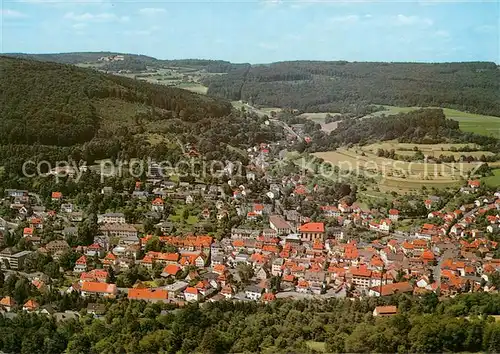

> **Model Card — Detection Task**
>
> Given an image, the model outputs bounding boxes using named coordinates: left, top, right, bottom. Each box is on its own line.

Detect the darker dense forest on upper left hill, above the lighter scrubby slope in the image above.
left=0, top=57, right=231, bottom=146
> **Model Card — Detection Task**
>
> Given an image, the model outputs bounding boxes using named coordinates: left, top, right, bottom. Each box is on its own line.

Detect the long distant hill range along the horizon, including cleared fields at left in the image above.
left=8, top=52, right=500, bottom=116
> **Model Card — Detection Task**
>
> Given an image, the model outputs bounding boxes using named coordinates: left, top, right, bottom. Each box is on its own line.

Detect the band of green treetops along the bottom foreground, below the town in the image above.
left=0, top=293, right=500, bottom=354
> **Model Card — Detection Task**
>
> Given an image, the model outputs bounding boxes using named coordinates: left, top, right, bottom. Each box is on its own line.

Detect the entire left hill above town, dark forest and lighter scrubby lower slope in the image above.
left=0, top=57, right=275, bottom=173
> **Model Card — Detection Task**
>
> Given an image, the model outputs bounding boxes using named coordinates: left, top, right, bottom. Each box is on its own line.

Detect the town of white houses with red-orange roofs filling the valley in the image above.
left=0, top=140, right=500, bottom=315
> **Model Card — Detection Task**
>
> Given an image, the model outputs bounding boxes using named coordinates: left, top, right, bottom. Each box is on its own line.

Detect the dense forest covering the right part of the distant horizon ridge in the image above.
left=205, top=61, right=500, bottom=116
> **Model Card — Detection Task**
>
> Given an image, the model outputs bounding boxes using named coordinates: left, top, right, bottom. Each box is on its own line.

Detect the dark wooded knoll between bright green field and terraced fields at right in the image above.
left=290, top=108, right=500, bottom=154
